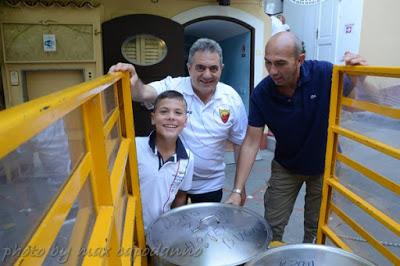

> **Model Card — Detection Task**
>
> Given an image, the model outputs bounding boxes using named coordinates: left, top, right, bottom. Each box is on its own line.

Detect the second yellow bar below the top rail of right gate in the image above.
left=332, top=126, right=400, bottom=160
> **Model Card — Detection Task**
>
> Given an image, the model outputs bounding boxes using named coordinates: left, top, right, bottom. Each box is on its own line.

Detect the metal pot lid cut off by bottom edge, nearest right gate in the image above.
left=246, top=244, right=375, bottom=266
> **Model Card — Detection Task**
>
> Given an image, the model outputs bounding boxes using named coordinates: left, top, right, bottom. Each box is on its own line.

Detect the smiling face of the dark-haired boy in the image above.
left=151, top=98, right=187, bottom=138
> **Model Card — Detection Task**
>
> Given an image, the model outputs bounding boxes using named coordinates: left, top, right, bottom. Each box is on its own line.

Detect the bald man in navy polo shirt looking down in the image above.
left=228, top=32, right=366, bottom=243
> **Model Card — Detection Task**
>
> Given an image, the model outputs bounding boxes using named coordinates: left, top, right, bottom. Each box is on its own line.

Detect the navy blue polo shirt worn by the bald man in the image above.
left=249, top=60, right=350, bottom=175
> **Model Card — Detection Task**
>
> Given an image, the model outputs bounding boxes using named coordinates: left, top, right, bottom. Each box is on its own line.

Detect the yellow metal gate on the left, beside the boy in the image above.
left=0, top=71, right=147, bottom=265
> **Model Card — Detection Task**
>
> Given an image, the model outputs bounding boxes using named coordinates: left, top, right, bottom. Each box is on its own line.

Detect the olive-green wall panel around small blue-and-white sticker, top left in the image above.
left=3, top=23, right=94, bottom=62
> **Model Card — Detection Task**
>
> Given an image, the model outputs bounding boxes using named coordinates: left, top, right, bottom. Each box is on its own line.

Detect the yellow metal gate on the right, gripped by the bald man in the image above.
left=317, top=66, right=400, bottom=265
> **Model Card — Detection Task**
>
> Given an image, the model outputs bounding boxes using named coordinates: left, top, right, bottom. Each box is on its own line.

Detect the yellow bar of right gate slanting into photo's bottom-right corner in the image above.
left=330, top=203, right=400, bottom=265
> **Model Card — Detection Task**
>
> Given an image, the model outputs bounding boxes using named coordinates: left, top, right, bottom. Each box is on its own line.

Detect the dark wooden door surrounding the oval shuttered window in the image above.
left=102, top=14, right=185, bottom=136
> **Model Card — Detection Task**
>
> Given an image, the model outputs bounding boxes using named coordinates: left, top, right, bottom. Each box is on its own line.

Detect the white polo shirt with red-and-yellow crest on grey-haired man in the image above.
left=149, top=77, right=247, bottom=194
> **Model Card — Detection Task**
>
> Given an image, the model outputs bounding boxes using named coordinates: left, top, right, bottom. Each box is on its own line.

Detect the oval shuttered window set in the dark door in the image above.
left=121, top=34, right=168, bottom=66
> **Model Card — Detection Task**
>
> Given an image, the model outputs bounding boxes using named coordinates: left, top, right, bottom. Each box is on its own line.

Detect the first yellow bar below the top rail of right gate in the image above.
left=342, top=97, right=400, bottom=119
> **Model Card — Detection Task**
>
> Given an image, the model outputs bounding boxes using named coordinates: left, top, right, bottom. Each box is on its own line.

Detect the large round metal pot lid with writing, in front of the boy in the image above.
left=147, top=203, right=272, bottom=266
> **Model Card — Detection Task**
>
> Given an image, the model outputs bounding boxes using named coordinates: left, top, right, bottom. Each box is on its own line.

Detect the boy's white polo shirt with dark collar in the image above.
left=136, top=131, right=193, bottom=230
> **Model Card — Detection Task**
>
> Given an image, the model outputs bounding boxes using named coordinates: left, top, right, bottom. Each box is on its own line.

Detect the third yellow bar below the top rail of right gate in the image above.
left=336, top=153, right=400, bottom=194
